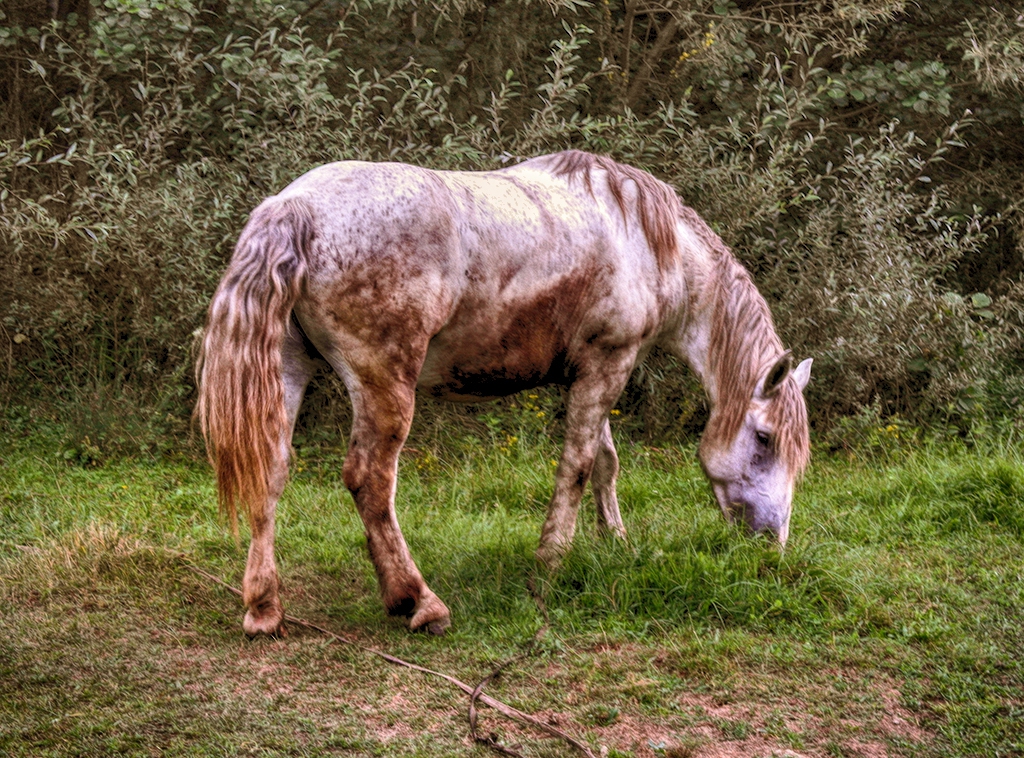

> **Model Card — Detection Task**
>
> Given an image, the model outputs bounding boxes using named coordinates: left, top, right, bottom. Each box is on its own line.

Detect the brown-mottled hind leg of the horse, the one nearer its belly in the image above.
left=343, top=384, right=450, bottom=634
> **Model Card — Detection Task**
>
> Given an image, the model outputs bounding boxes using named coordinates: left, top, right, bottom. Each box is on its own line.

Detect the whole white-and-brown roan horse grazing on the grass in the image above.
left=197, top=151, right=811, bottom=636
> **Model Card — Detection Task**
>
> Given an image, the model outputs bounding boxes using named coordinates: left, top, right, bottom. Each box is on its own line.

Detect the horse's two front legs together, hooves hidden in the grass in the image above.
left=537, top=351, right=635, bottom=567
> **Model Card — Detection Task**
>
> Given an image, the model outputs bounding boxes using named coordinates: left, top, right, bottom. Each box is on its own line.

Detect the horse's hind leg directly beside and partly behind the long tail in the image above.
left=242, top=323, right=317, bottom=637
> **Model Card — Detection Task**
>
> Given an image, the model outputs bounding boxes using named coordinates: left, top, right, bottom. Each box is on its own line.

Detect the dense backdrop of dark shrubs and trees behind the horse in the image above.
left=0, top=0, right=1024, bottom=460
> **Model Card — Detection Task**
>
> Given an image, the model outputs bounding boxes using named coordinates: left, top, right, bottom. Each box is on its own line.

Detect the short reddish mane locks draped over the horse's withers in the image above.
left=553, top=150, right=683, bottom=270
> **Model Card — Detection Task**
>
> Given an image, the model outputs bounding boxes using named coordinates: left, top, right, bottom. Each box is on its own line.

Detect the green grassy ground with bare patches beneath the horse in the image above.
left=0, top=419, right=1024, bottom=758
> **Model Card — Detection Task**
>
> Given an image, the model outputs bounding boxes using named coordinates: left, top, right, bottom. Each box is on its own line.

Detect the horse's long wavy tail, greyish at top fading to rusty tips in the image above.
left=196, top=199, right=313, bottom=534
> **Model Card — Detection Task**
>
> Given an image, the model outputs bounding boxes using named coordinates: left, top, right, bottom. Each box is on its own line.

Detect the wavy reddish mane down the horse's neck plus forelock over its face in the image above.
left=683, top=208, right=810, bottom=475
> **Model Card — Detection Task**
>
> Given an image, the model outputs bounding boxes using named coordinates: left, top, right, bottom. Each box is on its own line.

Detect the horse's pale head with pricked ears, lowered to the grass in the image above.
left=700, top=351, right=811, bottom=545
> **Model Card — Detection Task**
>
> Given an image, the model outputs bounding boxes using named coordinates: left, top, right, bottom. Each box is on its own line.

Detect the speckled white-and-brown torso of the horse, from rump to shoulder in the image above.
left=278, top=159, right=658, bottom=399
